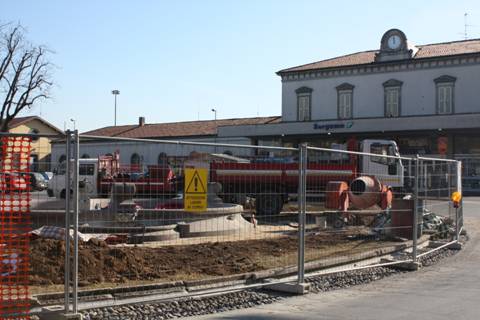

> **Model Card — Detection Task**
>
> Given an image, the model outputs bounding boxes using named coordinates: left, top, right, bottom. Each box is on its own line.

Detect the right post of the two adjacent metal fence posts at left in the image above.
left=72, top=130, right=80, bottom=314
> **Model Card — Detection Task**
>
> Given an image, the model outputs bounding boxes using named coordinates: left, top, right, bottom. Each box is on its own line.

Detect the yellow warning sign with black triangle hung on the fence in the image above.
left=184, top=168, right=208, bottom=211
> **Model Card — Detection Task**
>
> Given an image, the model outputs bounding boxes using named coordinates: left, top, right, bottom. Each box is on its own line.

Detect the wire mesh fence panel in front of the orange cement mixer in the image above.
left=305, top=145, right=415, bottom=270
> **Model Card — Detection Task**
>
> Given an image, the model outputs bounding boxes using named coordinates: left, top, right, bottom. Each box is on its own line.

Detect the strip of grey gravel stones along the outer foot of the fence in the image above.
left=81, top=249, right=457, bottom=320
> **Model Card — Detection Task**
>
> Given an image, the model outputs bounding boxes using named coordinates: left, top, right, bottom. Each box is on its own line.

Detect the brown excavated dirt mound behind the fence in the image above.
left=31, top=231, right=376, bottom=286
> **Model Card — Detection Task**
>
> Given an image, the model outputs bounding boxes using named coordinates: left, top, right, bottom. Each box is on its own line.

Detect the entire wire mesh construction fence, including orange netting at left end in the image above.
left=0, top=131, right=463, bottom=318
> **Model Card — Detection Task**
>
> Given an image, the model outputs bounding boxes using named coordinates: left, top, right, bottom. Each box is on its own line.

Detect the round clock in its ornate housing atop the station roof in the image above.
left=375, top=29, right=417, bottom=62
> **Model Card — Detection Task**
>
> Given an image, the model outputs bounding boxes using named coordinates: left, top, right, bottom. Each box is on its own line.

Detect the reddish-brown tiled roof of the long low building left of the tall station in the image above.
left=83, top=116, right=281, bottom=139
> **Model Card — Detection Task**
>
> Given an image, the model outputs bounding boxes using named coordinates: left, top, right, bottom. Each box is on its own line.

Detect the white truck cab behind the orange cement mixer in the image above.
left=358, top=139, right=404, bottom=188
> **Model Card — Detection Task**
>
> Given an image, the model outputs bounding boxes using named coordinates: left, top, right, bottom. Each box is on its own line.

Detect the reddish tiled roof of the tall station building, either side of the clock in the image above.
left=277, top=39, right=480, bottom=74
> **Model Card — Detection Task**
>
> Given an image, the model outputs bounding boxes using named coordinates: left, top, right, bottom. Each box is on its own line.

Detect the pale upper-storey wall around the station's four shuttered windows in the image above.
left=282, top=64, right=480, bottom=121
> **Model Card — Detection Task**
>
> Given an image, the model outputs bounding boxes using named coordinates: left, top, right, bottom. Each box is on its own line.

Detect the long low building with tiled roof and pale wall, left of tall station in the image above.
left=52, top=116, right=280, bottom=167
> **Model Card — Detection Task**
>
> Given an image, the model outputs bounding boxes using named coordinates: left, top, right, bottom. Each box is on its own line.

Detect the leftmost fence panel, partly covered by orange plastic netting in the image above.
left=0, top=133, right=68, bottom=319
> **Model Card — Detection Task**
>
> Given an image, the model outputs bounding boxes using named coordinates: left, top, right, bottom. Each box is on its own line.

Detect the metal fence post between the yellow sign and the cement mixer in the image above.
left=297, top=143, right=308, bottom=284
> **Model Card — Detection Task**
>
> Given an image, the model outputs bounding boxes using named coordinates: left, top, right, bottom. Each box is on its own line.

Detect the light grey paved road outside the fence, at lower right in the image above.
left=191, top=197, right=480, bottom=320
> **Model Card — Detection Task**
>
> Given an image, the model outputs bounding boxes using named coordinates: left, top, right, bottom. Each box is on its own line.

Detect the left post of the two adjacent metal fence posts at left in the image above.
left=64, top=130, right=71, bottom=313
